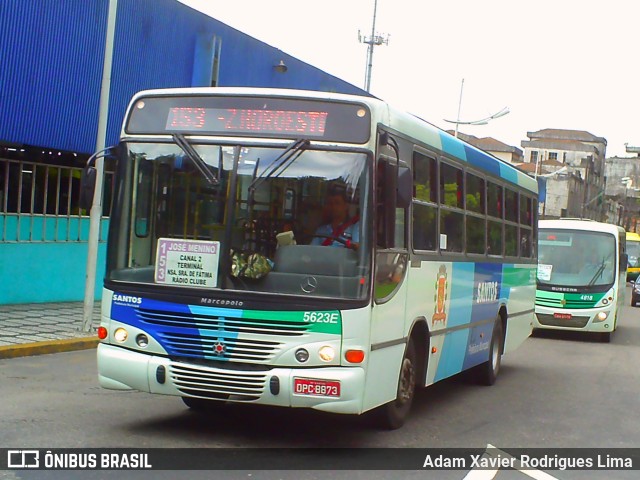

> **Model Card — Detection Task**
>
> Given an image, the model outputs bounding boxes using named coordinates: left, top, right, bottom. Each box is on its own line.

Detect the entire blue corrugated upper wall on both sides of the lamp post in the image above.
left=0, top=0, right=365, bottom=153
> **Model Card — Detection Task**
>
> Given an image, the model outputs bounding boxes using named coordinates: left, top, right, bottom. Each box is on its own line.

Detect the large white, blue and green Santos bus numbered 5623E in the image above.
left=91, top=88, right=537, bottom=428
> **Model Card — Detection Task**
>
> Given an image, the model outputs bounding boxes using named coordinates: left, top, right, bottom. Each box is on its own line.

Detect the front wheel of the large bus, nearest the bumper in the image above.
left=376, top=340, right=418, bottom=430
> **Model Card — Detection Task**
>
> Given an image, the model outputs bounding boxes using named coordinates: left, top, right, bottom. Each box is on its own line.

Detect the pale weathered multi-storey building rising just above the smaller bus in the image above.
left=521, top=129, right=607, bottom=220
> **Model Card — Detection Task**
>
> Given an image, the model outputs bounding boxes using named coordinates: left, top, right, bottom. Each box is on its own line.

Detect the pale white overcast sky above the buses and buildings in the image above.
left=180, top=0, right=640, bottom=157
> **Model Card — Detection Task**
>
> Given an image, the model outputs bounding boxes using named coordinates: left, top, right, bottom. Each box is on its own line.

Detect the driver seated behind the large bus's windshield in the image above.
left=311, top=187, right=360, bottom=250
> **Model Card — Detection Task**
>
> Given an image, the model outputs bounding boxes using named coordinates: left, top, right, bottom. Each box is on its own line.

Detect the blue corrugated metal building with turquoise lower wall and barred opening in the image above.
left=0, top=0, right=367, bottom=304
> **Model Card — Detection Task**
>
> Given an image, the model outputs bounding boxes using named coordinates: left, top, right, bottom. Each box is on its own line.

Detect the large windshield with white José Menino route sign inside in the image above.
left=107, top=141, right=371, bottom=299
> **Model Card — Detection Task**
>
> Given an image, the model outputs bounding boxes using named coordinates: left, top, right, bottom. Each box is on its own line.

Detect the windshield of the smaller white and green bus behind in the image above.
left=538, top=228, right=616, bottom=290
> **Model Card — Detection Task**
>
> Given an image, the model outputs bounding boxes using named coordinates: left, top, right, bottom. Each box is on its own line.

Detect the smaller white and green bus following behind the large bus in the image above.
left=535, top=219, right=627, bottom=342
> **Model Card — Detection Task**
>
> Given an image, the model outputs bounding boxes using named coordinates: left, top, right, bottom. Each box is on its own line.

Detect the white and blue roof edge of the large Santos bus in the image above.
left=122, top=87, right=538, bottom=193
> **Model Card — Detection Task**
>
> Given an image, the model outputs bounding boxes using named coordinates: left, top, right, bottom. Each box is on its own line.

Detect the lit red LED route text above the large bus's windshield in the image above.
left=166, top=107, right=329, bottom=137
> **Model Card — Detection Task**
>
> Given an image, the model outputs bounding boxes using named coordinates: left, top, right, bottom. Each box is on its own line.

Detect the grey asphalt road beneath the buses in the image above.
left=0, top=286, right=640, bottom=479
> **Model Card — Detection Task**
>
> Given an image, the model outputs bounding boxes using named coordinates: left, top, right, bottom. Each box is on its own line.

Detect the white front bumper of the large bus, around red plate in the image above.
left=98, top=343, right=365, bottom=414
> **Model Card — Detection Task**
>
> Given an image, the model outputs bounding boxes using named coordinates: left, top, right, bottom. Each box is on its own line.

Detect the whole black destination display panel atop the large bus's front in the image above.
left=125, top=95, right=372, bottom=144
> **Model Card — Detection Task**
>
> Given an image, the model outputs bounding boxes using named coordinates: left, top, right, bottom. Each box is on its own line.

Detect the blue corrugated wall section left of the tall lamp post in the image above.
left=0, top=0, right=107, bottom=152
